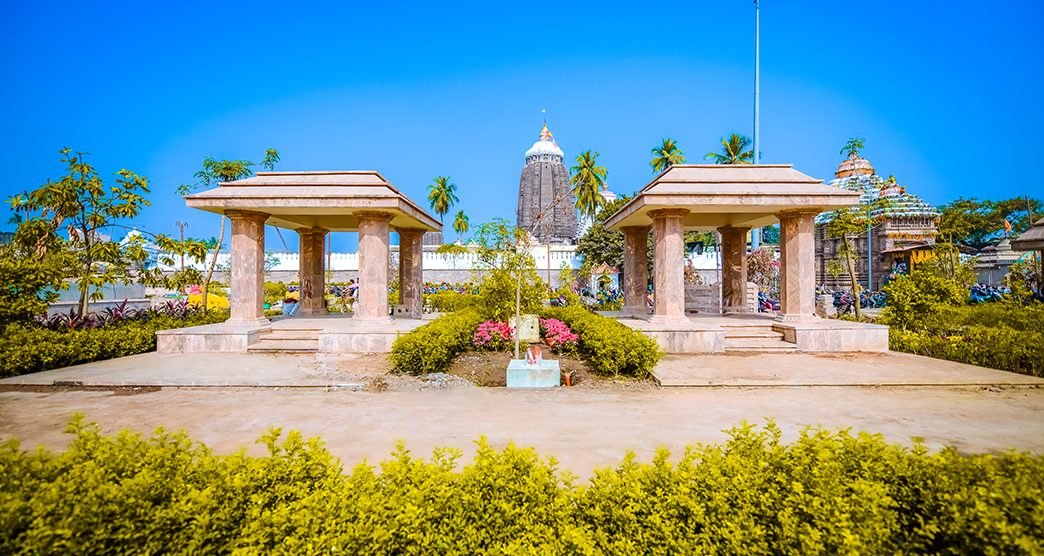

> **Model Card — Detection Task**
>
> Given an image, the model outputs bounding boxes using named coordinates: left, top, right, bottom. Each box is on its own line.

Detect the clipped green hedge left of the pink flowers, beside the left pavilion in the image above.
left=390, top=309, right=482, bottom=374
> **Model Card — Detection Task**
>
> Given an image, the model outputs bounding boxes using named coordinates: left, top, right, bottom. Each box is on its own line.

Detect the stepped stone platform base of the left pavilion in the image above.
left=157, top=313, right=431, bottom=354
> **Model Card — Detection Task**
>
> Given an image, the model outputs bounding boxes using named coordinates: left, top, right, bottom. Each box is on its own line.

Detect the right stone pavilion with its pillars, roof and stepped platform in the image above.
left=606, top=165, right=887, bottom=353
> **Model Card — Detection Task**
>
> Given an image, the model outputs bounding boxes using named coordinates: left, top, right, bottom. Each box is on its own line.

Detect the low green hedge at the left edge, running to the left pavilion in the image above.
left=0, top=312, right=229, bottom=377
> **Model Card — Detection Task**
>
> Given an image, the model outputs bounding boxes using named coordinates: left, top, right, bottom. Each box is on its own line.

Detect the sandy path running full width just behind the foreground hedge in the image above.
left=0, top=379, right=1044, bottom=476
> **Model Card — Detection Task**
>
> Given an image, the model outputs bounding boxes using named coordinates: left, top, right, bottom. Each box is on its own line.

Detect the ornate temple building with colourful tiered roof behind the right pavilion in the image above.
left=815, top=152, right=939, bottom=290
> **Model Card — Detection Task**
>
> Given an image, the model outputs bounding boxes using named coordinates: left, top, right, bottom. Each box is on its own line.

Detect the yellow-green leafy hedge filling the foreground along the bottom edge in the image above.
left=0, top=421, right=1044, bottom=555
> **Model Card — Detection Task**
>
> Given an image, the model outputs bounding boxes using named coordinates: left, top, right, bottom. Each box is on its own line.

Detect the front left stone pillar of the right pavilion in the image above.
left=648, top=209, right=689, bottom=323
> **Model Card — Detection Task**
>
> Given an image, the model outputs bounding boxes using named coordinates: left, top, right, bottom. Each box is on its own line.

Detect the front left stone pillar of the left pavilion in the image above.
left=224, top=211, right=268, bottom=327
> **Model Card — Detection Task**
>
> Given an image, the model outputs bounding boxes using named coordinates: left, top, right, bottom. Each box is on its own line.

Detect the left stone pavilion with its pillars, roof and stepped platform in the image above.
left=158, top=171, right=442, bottom=352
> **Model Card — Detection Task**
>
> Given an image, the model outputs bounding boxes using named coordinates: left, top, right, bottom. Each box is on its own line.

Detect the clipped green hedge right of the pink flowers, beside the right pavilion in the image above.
left=541, top=307, right=663, bottom=379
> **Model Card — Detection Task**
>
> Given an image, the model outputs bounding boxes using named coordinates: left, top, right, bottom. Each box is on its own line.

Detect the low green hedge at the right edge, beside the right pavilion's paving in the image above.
left=888, top=324, right=1044, bottom=377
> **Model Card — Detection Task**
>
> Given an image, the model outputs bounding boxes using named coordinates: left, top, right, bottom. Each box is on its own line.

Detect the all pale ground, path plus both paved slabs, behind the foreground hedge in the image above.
left=0, top=354, right=1044, bottom=475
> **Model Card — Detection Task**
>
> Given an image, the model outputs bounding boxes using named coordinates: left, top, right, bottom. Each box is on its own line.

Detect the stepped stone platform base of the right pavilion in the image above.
left=618, top=313, right=888, bottom=354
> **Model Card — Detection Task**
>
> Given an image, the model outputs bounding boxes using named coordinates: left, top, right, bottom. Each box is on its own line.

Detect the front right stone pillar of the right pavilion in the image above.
left=776, top=211, right=818, bottom=321
